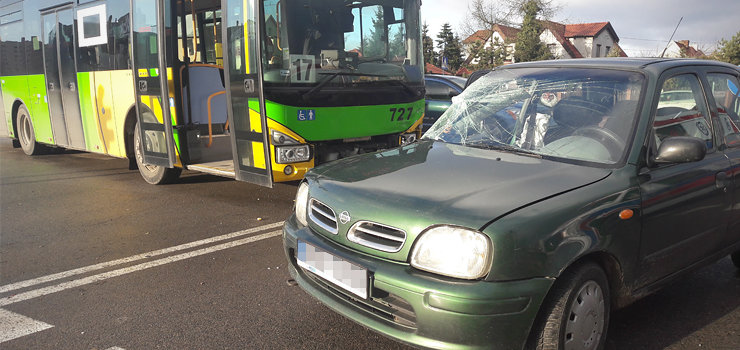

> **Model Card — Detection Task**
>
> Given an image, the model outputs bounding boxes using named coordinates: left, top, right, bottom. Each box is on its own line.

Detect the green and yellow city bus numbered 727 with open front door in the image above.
left=0, top=0, right=425, bottom=187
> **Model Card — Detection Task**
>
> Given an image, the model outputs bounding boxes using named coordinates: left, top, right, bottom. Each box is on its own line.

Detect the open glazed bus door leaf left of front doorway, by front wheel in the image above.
left=131, top=0, right=177, bottom=168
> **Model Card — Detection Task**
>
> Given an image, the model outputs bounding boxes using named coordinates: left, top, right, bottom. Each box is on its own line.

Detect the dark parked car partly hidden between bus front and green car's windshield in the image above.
left=422, top=74, right=467, bottom=132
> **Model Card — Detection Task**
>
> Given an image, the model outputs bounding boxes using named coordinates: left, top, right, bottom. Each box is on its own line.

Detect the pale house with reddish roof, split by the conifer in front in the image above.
left=463, top=21, right=627, bottom=64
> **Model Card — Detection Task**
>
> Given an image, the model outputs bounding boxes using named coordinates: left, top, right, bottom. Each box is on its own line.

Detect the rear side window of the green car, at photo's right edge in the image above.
left=707, top=73, right=740, bottom=147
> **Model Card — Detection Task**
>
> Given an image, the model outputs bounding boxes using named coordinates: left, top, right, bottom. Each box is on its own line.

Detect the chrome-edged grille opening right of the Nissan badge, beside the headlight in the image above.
left=347, top=221, right=406, bottom=253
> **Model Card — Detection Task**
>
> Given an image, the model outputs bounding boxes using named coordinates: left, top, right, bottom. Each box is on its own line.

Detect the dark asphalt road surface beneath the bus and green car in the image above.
left=0, top=139, right=740, bottom=350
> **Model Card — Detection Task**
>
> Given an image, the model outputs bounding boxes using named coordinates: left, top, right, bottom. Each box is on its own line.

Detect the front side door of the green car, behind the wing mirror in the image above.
left=637, top=69, right=732, bottom=287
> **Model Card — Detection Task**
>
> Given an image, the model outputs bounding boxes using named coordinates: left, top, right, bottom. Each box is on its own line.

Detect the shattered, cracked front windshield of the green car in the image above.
left=424, top=68, right=644, bottom=164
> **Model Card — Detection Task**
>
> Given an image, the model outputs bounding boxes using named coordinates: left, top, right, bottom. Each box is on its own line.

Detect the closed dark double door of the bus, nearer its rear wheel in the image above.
left=41, top=6, right=86, bottom=150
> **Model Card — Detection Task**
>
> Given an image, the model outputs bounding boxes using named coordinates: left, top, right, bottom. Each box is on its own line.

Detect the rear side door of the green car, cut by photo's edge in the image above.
left=705, top=69, right=740, bottom=247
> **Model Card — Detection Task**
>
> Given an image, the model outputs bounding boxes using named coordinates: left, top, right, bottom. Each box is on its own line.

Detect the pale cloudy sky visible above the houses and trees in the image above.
left=421, top=0, right=740, bottom=56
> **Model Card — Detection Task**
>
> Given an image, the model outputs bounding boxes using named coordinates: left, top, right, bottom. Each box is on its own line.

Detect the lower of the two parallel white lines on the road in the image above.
left=0, top=231, right=282, bottom=307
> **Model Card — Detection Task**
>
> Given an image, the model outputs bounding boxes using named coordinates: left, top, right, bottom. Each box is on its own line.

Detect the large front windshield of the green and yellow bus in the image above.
left=262, top=0, right=424, bottom=87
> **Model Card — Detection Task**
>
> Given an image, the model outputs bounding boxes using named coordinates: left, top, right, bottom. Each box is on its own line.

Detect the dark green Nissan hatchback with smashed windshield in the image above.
left=283, top=58, right=740, bottom=350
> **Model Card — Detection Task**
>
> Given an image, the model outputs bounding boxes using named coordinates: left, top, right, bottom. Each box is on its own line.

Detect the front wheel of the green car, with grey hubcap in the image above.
left=526, top=262, right=610, bottom=350
